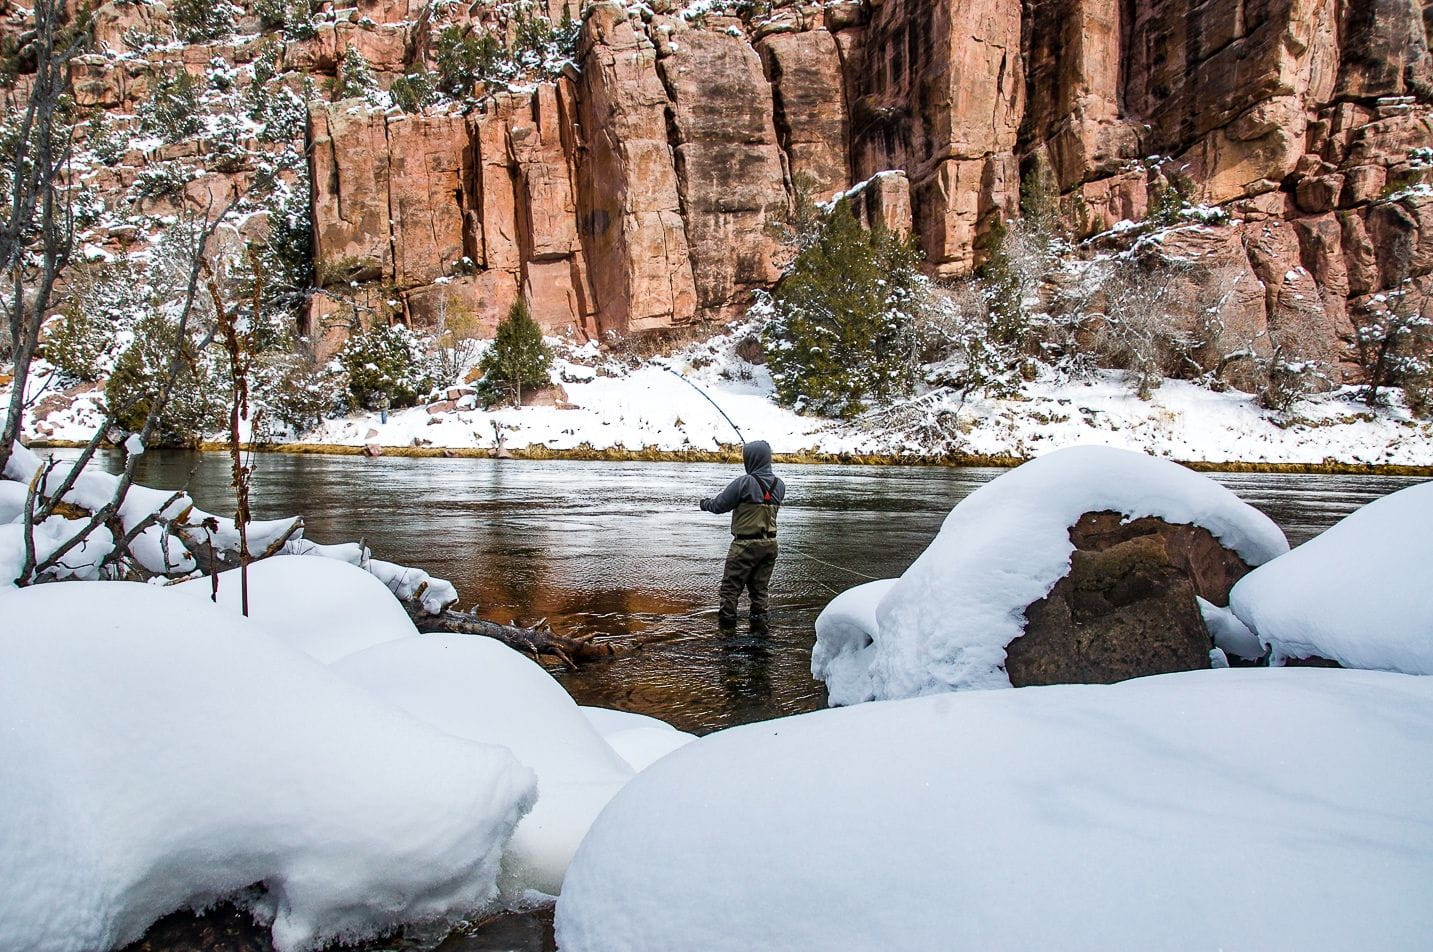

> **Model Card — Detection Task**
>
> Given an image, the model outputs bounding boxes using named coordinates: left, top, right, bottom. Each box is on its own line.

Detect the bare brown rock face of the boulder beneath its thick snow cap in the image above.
left=1006, top=512, right=1250, bottom=687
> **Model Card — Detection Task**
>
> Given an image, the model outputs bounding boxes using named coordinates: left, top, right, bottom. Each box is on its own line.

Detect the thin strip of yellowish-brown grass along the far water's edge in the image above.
left=19, top=440, right=1433, bottom=476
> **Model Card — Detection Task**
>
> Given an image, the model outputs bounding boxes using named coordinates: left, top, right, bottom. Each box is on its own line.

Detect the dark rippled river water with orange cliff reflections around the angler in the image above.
left=86, top=452, right=1419, bottom=733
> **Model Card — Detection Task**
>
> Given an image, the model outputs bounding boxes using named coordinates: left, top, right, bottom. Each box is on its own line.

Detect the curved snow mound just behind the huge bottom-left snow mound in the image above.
left=332, top=635, right=632, bottom=902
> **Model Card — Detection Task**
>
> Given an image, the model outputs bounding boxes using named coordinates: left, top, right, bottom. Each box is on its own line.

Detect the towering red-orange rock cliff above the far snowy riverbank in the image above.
left=30, top=0, right=1433, bottom=372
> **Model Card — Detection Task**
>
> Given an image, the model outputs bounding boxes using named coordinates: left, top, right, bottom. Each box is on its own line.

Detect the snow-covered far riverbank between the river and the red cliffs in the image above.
left=11, top=326, right=1433, bottom=467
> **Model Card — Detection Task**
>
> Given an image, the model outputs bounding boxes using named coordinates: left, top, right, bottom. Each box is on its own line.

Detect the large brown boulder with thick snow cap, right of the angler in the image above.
left=811, top=446, right=1288, bottom=704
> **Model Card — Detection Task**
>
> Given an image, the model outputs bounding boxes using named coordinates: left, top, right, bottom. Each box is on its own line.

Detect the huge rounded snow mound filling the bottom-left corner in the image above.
left=0, top=582, right=535, bottom=952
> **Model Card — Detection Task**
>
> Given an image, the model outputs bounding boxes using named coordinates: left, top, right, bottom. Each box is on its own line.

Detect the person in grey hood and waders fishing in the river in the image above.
left=701, top=440, right=787, bottom=631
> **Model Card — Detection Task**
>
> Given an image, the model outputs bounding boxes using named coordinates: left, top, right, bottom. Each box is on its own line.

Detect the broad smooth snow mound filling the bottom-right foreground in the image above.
left=557, top=668, right=1433, bottom=952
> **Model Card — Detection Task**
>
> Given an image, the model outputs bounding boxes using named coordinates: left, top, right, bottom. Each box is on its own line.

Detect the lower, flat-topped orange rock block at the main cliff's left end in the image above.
left=310, top=82, right=598, bottom=334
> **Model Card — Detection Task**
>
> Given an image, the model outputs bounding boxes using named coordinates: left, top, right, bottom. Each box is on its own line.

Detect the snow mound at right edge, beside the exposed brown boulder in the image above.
left=1230, top=482, right=1433, bottom=674
